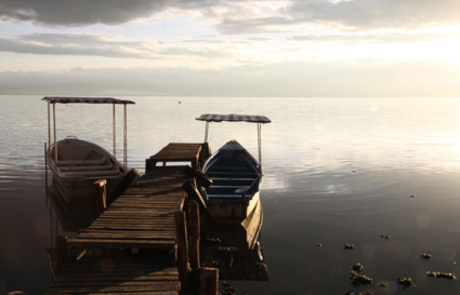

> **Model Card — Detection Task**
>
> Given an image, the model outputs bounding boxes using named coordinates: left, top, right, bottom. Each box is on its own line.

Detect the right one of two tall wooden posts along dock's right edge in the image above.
left=188, top=200, right=200, bottom=268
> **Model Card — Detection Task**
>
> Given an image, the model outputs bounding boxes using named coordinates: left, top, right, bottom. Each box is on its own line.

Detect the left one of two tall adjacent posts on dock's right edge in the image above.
left=174, top=211, right=190, bottom=285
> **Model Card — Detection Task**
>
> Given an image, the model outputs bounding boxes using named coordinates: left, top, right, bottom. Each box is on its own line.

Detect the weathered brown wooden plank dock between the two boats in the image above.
left=46, top=144, right=218, bottom=295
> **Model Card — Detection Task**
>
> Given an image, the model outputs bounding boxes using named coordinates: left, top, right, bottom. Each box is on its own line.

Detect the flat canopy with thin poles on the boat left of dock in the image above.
left=42, top=96, right=135, bottom=168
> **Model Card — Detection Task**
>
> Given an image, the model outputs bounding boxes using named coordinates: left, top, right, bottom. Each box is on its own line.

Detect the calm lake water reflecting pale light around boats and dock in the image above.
left=0, top=96, right=460, bottom=295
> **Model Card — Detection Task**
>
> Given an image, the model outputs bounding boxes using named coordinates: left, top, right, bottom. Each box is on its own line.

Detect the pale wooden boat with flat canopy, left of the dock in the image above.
left=42, top=97, right=134, bottom=204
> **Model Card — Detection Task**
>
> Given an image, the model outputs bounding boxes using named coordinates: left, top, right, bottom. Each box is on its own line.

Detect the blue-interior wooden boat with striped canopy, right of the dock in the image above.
left=197, top=114, right=270, bottom=224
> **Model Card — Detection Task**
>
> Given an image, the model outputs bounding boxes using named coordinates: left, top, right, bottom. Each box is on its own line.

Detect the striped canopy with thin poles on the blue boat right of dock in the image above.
left=196, top=114, right=271, bottom=166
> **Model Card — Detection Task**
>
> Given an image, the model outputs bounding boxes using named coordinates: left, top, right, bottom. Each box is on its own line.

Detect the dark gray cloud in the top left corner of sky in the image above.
left=0, top=0, right=216, bottom=26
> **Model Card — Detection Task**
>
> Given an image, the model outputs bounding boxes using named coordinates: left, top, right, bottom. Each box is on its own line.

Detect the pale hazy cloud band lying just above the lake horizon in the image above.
left=0, top=61, right=460, bottom=97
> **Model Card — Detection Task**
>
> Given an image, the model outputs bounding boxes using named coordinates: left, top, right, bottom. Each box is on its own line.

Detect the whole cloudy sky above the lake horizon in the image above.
left=0, top=0, right=460, bottom=97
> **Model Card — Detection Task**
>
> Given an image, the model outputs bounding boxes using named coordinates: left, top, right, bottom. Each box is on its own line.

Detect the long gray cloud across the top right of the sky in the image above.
left=216, top=0, right=460, bottom=34
